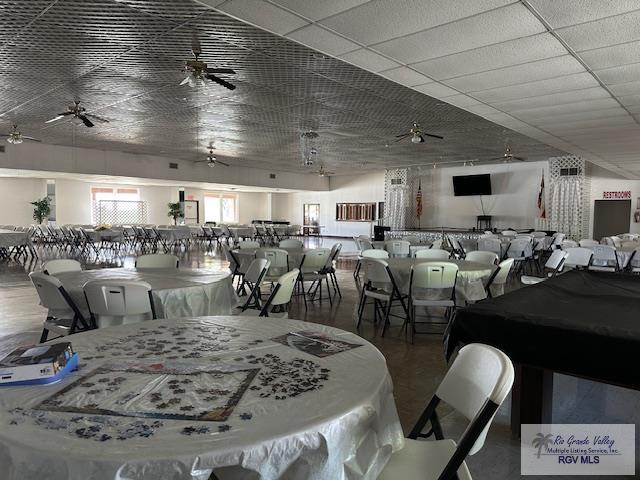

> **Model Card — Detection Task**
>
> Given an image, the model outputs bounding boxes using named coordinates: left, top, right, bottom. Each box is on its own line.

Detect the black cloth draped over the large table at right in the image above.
left=446, top=271, right=640, bottom=389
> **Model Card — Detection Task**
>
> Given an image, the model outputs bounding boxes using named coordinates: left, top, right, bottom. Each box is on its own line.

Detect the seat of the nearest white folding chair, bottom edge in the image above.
left=378, top=439, right=471, bottom=480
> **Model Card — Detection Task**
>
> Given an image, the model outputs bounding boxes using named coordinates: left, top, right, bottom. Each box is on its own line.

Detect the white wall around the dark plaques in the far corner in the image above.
left=271, top=172, right=384, bottom=237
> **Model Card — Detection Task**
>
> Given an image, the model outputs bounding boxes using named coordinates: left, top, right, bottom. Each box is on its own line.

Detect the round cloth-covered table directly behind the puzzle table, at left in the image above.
left=55, top=268, right=239, bottom=318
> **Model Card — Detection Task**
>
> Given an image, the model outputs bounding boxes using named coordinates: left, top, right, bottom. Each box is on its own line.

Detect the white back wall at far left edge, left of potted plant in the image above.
left=0, top=177, right=47, bottom=225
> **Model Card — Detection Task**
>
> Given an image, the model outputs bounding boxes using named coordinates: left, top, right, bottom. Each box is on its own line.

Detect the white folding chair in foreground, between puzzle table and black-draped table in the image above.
left=378, top=343, right=514, bottom=480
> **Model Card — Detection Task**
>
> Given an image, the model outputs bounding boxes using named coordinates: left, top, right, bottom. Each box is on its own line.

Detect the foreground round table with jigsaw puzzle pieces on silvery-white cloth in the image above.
left=0, top=317, right=404, bottom=480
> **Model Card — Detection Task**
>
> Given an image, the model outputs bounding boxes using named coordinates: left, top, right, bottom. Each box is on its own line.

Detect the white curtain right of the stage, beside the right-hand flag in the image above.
left=550, top=176, right=582, bottom=237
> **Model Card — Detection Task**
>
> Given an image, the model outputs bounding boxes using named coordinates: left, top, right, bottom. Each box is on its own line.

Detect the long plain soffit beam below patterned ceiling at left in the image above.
left=0, top=142, right=329, bottom=190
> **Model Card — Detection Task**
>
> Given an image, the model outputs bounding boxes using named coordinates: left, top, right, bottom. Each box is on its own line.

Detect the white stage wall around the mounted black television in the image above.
left=418, top=162, right=549, bottom=228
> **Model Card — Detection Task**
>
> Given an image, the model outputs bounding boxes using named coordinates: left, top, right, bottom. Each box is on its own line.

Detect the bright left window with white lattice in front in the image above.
left=91, top=187, right=147, bottom=224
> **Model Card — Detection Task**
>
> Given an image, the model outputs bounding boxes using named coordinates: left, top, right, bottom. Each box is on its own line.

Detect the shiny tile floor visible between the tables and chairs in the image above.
left=0, top=238, right=640, bottom=480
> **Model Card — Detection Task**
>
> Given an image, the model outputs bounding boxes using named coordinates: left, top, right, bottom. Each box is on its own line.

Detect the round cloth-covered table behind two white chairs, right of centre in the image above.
left=385, top=258, right=496, bottom=301
